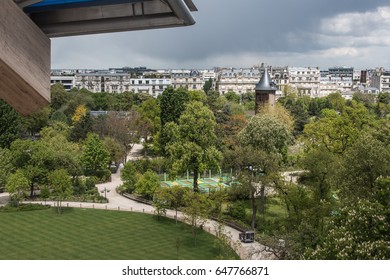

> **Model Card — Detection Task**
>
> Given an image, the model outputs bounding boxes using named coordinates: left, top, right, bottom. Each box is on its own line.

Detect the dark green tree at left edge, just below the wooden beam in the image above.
left=0, top=99, right=21, bottom=148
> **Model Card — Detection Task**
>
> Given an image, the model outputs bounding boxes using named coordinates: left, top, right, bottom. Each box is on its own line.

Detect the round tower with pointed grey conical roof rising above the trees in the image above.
left=255, top=68, right=276, bottom=114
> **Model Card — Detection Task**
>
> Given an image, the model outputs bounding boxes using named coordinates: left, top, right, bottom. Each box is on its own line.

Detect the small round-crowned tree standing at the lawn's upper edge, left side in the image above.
left=48, top=169, right=73, bottom=214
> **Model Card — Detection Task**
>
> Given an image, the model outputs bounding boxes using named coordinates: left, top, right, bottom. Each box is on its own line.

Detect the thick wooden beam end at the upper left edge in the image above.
left=0, top=0, right=50, bottom=115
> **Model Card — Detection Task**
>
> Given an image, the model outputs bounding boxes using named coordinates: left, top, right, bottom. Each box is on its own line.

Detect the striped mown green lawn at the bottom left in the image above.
left=0, top=208, right=238, bottom=260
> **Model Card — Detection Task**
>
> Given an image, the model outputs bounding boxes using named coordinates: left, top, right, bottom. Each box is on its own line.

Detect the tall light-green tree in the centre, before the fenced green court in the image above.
left=166, top=102, right=221, bottom=191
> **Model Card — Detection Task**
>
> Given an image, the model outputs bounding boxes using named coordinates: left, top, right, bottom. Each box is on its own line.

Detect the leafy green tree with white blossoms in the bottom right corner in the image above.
left=305, top=199, right=390, bottom=260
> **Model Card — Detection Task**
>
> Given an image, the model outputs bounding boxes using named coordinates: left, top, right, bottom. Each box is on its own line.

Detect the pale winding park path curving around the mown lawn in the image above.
left=3, top=144, right=274, bottom=260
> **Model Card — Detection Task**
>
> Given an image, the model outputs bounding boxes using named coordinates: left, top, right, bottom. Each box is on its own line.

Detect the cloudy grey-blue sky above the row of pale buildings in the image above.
left=52, top=0, right=390, bottom=69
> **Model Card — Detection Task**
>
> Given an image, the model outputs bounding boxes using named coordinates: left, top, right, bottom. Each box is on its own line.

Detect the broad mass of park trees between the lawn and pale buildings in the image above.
left=0, top=85, right=390, bottom=259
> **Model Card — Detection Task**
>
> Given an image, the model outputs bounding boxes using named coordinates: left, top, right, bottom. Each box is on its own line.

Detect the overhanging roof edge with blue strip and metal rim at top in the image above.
left=14, top=0, right=197, bottom=37
